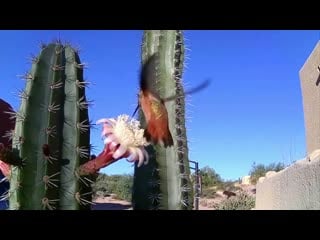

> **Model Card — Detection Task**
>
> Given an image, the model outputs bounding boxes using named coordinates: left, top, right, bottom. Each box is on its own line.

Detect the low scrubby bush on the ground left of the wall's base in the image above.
left=215, top=192, right=255, bottom=210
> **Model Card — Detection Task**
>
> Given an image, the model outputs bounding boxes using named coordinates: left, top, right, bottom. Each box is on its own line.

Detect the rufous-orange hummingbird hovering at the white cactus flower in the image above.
left=132, top=54, right=209, bottom=147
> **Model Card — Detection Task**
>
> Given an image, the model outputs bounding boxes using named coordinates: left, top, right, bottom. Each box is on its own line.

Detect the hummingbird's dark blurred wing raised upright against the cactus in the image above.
left=140, top=53, right=161, bottom=101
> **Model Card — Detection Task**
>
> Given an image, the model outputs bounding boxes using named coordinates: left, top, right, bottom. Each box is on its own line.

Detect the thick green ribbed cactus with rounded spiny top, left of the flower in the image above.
left=9, top=41, right=91, bottom=210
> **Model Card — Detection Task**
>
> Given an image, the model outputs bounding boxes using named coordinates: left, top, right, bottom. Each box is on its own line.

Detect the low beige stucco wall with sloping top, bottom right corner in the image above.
left=255, top=150, right=320, bottom=210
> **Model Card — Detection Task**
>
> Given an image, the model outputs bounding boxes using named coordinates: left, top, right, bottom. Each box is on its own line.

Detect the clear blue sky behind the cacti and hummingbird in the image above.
left=0, top=30, right=320, bottom=179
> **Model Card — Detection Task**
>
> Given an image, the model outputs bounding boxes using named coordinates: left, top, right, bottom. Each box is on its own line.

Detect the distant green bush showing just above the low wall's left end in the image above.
left=249, top=162, right=286, bottom=184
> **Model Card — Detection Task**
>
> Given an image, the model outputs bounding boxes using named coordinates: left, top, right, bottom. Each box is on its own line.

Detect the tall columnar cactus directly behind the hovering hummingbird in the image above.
left=132, top=30, right=193, bottom=210
